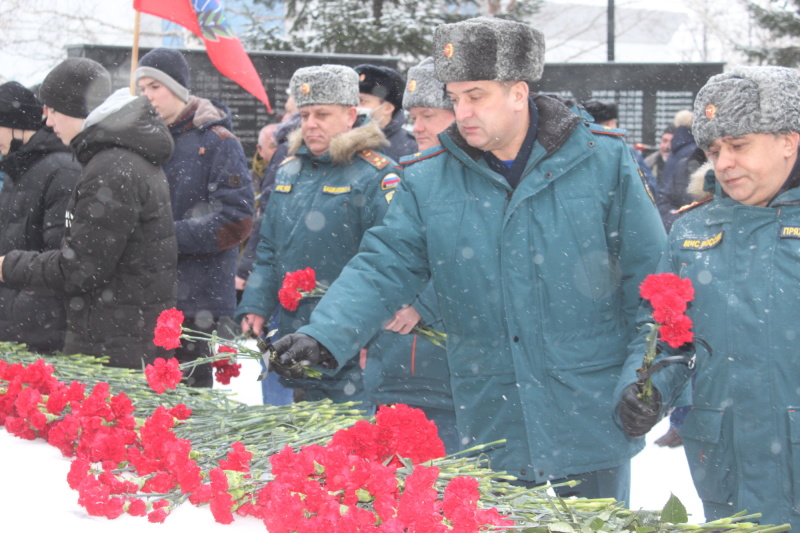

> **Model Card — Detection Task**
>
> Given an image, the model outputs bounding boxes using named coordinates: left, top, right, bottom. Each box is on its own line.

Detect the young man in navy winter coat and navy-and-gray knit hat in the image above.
left=134, top=48, right=254, bottom=387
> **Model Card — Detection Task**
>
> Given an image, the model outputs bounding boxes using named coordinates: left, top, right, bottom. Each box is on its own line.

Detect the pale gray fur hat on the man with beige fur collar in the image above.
left=289, top=65, right=358, bottom=108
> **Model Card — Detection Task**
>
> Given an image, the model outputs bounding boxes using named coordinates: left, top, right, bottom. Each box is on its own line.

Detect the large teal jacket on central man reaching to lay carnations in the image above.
left=300, top=96, right=665, bottom=482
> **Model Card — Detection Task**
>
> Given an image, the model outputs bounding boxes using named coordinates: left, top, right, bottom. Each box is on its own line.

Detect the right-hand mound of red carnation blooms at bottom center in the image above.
left=255, top=405, right=513, bottom=533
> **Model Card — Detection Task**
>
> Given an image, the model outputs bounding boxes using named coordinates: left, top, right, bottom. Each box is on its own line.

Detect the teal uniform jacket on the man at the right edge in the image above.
left=620, top=177, right=800, bottom=528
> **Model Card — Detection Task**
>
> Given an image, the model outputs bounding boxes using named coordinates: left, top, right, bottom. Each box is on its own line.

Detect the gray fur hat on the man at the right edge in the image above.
left=692, top=67, right=800, bottom=150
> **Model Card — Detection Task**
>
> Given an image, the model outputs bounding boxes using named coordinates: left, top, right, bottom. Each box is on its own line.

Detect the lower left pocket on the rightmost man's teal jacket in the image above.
left=680, top=407, right=738, bottom=504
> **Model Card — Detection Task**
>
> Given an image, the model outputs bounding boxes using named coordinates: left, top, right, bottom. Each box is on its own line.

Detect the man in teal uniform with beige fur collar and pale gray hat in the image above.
left=236, top=65, right=400, bottom=401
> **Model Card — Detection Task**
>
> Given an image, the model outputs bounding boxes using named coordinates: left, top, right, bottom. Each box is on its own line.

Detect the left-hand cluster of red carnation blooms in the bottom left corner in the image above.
left=0, top=359, right=202, bottom=522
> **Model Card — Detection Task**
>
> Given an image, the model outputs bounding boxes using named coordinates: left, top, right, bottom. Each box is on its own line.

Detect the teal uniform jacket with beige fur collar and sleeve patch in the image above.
left=236, top=123, right=401, bottom=402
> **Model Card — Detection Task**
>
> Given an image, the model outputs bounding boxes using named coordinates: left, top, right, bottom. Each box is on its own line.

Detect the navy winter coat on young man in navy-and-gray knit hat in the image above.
left=164, top=96, right=254, bottom=319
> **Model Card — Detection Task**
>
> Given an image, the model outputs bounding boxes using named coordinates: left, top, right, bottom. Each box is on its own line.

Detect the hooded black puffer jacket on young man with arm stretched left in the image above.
left=3, top=92, right=178, bottom=368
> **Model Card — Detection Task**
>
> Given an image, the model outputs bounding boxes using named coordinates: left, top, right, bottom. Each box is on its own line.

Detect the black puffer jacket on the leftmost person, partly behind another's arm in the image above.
left=0, top=127, right=81, bottom=353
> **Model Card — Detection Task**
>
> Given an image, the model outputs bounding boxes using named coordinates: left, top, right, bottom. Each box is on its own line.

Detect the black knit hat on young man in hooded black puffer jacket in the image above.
left=39, top=57, right=111, bottom=118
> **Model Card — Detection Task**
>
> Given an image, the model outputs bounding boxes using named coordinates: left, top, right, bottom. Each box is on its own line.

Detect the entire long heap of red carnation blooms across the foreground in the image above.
left=0, top=359, right=513, bottom=533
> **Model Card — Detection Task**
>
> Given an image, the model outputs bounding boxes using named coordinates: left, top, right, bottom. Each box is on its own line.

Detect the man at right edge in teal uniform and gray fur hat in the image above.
left=617, top=67, right=800, bottom=527
